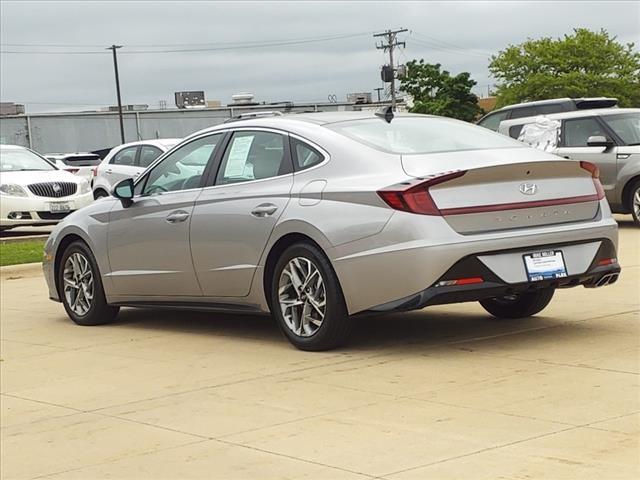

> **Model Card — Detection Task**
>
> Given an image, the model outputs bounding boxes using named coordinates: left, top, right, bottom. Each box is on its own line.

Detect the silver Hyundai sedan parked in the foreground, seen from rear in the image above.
left=44, top=111, right=620, bottom=350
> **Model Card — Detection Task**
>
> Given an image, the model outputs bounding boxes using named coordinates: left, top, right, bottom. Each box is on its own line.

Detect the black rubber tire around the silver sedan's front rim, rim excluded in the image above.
left=57, top=241, right=120, bottom=326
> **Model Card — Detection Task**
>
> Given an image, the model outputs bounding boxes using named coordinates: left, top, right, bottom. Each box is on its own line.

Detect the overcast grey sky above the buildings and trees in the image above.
left=0, top=0, right=640, bottom=113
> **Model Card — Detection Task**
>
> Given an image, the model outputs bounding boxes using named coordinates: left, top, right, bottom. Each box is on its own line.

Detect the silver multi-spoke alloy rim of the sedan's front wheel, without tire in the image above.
left=62, top=252, right=93, bottom=316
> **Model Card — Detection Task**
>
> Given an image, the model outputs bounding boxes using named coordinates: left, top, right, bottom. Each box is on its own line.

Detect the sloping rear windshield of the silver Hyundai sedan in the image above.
left=327, top=116, right=523, bottom=154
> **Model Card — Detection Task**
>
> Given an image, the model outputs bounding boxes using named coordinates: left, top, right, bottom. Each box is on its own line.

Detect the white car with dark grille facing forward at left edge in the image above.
left=0, top=145, right=93, bottom=230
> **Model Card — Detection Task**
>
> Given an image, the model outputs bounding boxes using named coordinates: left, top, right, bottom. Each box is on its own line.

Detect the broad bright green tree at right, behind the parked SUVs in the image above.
left=489, top=28, right=640, bottom=107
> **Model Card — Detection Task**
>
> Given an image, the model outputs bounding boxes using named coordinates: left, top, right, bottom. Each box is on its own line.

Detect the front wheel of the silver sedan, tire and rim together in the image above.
left=58, top=241, right=119, bottom=326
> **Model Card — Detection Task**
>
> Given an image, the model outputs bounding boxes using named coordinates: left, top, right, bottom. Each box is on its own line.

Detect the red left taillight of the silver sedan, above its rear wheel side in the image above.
left=378, top=171, right=466, bottom=215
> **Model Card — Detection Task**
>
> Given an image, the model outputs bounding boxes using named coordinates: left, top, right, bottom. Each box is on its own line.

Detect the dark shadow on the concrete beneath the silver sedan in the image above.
left=106, top=308, right=564, bottom=352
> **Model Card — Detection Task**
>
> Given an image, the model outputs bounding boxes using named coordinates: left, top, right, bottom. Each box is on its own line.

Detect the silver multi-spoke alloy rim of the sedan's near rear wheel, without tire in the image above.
left=278, top=257, right=327, bottom=337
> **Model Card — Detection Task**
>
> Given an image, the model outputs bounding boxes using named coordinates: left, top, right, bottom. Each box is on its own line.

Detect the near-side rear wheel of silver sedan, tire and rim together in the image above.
left=270, top=243, right=351, bottom=351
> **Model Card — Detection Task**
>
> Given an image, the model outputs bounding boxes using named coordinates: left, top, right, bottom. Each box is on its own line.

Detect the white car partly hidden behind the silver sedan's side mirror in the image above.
left=91, top=138, right=180, bottom=199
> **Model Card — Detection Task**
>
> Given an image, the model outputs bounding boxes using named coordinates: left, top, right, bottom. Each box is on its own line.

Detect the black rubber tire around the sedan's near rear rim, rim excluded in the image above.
left=269, top=242, right=352, bottom=351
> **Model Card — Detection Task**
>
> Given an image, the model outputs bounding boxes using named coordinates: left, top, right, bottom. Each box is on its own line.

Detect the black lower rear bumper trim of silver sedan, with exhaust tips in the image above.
left=369, top=239, right=621, bottom=312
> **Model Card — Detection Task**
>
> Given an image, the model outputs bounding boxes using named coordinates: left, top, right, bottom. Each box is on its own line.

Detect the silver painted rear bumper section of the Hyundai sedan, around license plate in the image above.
left=327, top=206, right=618, bottom=315
